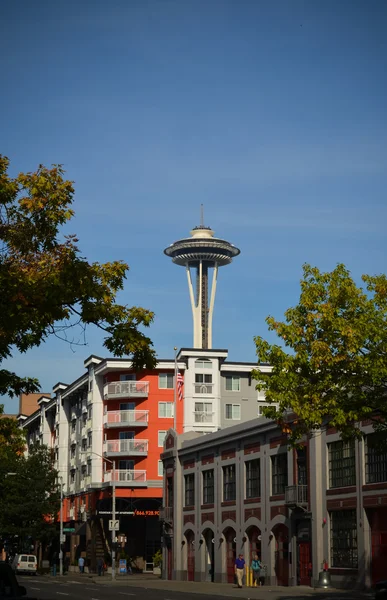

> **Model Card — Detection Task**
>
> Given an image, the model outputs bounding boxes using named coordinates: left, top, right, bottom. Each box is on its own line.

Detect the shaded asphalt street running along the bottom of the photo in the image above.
left=18, top=574, right=373, bottom=600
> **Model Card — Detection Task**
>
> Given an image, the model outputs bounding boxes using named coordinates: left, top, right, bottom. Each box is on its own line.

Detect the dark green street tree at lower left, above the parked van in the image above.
left=0, top=445, right=60, bottom=549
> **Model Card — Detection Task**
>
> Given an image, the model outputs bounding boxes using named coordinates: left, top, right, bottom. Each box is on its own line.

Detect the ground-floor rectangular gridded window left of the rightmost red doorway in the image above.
left=330, top=510, right=357, bottom=569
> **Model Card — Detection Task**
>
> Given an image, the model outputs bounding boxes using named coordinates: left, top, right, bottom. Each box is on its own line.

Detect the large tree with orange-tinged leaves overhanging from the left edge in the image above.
left=0, top=155, right=155, bottom=404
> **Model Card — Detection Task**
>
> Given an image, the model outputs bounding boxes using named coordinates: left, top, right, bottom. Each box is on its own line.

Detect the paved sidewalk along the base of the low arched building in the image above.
left=59, top=573, right=374, bottom=600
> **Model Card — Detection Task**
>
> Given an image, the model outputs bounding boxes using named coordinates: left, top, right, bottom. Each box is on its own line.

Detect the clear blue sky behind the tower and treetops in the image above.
left=0, top=0, right=387, bottom=412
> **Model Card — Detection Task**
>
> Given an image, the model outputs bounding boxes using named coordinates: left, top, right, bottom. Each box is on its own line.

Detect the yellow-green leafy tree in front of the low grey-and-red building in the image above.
left=254, top=264, right=387, bottom=443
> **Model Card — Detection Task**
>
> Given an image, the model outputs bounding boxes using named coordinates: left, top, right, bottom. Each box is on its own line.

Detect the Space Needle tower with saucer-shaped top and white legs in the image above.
left=164, top=205, right=240, bottom=349
